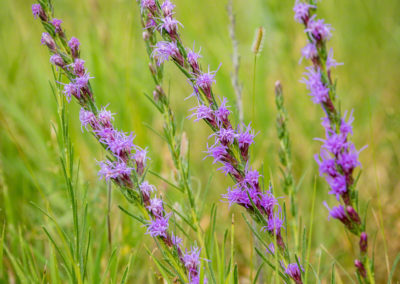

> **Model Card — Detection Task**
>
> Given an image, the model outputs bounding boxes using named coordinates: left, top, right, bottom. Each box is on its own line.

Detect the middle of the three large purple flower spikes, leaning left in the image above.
left=141, top=0, right=285, bottom=251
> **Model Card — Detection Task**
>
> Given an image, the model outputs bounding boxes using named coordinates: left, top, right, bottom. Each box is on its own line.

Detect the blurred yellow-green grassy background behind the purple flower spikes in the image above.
left=0, top=0, right=400, bottom=283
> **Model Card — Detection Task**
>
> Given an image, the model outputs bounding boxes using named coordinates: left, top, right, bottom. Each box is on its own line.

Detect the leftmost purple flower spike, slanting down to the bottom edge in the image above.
left=32, top=3, right=200, bottom=283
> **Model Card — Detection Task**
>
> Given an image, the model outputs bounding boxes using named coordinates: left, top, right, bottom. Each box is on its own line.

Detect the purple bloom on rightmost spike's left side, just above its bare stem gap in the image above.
left=301, top=67, right=329, bottom=104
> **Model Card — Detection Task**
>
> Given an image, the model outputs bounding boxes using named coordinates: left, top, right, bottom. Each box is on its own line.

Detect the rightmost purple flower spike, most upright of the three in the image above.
left=293, top=1, right=367, bottom=278
